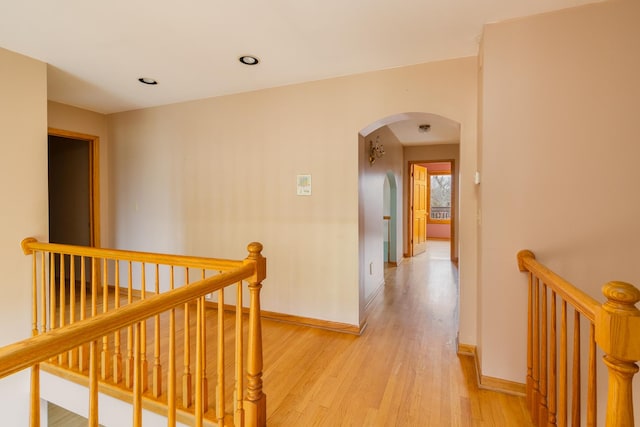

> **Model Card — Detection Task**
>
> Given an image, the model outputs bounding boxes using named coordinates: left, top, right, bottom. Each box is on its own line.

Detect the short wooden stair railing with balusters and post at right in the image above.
left=518, top=250, right=640, bottom=427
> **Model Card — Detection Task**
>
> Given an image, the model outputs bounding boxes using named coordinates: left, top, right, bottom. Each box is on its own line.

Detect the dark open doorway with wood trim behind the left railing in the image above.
left=48, top=129, right=100, bottom=247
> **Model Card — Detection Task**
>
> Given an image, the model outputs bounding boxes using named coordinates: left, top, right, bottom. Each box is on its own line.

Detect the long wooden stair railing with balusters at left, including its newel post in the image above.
left=0, top=238, right=266, bottom=426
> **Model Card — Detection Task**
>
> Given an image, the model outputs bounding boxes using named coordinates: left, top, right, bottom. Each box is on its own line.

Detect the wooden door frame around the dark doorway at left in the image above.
left=47, top=127, right=100, bottom=248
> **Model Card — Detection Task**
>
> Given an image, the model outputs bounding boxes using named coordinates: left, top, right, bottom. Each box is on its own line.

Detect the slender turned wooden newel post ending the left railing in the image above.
left=244, top=242, right=267, bottom=427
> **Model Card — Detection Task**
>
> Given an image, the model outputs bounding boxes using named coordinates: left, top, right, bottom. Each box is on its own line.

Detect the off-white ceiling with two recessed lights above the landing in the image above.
left=0, top=0, right=594, bottom=118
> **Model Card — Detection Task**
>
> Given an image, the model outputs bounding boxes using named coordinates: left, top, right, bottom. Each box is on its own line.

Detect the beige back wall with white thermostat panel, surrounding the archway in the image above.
left=108, top=58, right=476, bottom=328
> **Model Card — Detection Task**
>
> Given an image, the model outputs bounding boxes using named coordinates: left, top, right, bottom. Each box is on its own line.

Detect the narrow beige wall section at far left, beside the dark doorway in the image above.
left=0, top=48, right=48, bottom=425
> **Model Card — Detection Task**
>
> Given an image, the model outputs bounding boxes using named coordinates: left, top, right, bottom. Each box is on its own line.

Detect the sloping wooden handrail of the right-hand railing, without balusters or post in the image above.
left=518, top=249, right=600, bottom=322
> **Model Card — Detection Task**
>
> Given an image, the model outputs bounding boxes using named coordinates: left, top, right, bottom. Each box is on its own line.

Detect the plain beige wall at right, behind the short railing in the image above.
left=479, top=1, right=640, bottom=422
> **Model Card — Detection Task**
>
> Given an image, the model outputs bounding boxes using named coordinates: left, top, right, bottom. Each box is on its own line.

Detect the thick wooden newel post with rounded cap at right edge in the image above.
left=596, top=282, right=640, bottom=427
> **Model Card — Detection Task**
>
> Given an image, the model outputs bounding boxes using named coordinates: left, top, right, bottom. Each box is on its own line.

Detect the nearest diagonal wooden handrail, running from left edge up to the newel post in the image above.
left=0, top=265, right=254, bottom=378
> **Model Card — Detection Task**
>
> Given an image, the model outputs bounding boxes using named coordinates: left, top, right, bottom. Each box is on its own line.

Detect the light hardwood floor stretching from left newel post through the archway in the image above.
left=263, top=241, right=531, bottom=427
